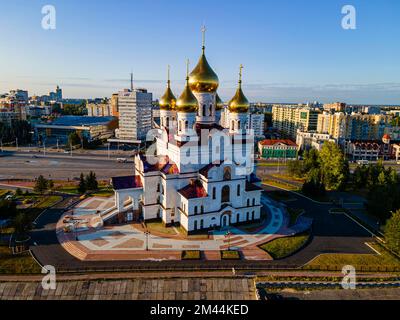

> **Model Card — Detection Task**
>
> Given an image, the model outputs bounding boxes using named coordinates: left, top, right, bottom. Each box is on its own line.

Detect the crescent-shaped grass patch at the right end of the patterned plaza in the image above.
left=260, top=232, right=310, bottom=259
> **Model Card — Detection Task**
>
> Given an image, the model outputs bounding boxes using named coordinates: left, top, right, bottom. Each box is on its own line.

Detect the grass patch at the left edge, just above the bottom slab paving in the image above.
left=0, top=246, right=41, bottom=274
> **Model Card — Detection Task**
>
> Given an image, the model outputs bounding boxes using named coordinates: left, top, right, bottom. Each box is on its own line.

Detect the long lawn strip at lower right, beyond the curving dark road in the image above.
left=303, top=243, right=400, bottom=270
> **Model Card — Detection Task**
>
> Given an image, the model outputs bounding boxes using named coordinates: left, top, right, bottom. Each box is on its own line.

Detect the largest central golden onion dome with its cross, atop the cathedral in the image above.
left=189, top=27, right=219, bottom=92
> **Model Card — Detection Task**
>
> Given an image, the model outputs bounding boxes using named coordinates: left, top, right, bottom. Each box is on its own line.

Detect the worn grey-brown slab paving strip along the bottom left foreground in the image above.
left=0, top=278, right=256, bottom=300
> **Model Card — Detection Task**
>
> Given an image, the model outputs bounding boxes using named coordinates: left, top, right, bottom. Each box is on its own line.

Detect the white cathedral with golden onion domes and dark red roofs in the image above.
left=101, top=32, right=262, bottom=234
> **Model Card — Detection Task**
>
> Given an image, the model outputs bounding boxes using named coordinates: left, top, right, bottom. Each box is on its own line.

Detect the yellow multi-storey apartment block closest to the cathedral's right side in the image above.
left=272, top=105, right=320, bottom=138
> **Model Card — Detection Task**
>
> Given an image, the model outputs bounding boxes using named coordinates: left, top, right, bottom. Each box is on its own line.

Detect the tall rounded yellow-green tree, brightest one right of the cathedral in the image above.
left=319, top=142, right=350, bottom=190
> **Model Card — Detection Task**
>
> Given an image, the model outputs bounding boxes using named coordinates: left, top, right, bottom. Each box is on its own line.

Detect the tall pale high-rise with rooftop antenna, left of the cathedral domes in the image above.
left=116, top=89, right=153, bottom=141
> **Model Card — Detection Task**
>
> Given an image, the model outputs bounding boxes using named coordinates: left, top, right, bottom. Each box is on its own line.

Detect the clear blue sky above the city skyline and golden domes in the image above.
left=0, top=0, right=400, bottom=104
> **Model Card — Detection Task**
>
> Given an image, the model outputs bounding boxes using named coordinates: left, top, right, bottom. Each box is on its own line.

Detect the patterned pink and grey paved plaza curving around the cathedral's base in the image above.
left=57, top=197, right=311, bottom=261
